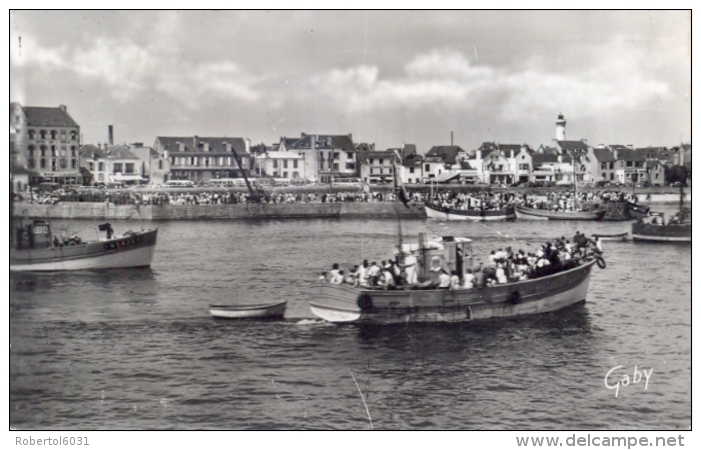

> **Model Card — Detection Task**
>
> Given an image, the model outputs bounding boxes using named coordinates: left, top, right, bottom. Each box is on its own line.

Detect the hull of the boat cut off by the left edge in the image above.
left=10, top=229, right=158, bottom=272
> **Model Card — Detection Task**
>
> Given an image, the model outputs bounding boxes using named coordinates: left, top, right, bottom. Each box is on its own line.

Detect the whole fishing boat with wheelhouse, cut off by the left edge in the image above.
left=10, top=219, right=158, bottom=272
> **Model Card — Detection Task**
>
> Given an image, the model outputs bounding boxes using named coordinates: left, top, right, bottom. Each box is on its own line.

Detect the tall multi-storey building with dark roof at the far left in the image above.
left=10, top=103, right=82, bottom=186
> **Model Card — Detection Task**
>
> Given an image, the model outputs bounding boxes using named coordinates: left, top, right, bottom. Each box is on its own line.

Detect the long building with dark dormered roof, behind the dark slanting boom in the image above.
left=153, top=136, right=253, bottom=183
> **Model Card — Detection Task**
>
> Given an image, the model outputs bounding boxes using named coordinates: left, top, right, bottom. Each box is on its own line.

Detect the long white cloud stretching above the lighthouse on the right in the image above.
left=307, top=45, right=669, bottom=121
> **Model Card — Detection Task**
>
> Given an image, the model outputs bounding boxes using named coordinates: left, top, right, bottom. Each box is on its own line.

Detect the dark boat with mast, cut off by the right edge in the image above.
left=631, top=188, right=691, bottom=243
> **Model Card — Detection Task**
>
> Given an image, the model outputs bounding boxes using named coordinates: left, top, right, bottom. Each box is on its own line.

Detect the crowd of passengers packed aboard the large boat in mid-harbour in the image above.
left=319, top=231, right=603, bottom=290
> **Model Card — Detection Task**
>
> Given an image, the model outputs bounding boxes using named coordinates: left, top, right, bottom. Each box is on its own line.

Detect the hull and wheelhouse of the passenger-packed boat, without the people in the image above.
left=310, top=234, right=605, bottom=324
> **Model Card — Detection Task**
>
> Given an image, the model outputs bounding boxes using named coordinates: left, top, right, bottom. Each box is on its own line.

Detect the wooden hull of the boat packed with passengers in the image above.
left=310, top=261, right=595, bottom=324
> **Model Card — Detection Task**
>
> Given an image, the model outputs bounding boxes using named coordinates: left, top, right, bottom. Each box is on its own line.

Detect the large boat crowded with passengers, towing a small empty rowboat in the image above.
left=310, top=232, right=606, bottom=324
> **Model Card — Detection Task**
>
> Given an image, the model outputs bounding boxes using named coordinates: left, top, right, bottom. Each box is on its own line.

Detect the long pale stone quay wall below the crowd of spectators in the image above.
left=14, top=202, right=426, bottom=221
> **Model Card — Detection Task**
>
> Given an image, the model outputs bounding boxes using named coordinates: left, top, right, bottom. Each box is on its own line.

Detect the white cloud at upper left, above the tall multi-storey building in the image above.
left=11, top=28, right=264, bottom=106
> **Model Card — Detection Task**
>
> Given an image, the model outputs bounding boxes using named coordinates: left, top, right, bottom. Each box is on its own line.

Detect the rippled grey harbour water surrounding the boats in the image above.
left=10, top=208, right=691, bottom=430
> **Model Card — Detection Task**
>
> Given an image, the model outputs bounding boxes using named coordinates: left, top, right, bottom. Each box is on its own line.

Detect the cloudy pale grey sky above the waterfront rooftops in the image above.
left=9, top=10, right=691, bottom=153
